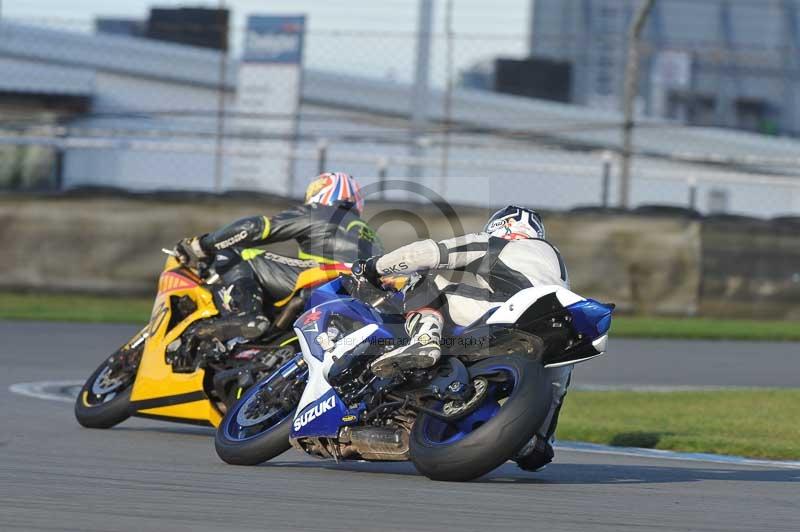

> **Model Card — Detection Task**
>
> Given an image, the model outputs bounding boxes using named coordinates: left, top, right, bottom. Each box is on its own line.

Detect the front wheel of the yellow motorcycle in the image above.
left=75, top=348, right=142, bottom=429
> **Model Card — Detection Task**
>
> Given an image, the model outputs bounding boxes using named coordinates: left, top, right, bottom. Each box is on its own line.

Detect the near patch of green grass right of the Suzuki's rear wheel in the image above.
left=557, top=389, right=800, bottom=460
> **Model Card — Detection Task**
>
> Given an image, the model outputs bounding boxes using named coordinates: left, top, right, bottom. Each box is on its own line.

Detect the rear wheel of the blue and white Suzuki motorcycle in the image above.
left=409, top=355, right=551, bottom=481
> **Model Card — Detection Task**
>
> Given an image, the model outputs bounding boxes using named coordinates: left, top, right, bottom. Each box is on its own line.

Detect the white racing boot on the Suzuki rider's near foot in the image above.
left=370, top=308, right=444, bottom=379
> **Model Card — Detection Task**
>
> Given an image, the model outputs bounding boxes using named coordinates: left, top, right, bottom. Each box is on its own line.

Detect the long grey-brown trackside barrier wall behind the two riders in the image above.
left=0, top=195, right=800, bottom=319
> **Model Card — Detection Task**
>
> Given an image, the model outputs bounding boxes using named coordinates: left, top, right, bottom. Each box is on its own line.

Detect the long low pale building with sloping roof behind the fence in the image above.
left=0, top=22, right=800, bottom=216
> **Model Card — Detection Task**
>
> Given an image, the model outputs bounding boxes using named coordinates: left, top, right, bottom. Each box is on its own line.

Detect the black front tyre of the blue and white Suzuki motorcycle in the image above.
left=214, top=411, right=294, bottom=465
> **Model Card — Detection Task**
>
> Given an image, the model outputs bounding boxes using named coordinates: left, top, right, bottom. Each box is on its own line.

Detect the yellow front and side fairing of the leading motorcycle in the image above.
left=131, top=257, right=221, bottom=426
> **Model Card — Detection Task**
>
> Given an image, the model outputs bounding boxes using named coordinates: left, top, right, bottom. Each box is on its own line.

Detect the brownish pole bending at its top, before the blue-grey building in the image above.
left=619, top=0, right=655, bottom=209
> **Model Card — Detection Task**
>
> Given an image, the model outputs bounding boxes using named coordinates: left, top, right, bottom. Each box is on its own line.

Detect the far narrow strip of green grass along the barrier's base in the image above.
left=0, top=292, right=800, bottom=341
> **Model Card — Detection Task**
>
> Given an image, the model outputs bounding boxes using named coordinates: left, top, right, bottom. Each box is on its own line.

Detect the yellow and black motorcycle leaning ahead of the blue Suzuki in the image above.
left=75, top=250, right=350, bottom=428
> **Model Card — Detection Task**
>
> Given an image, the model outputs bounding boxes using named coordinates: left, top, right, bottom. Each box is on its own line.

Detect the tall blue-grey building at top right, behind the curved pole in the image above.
left=530, top=0, right=800, bottom=136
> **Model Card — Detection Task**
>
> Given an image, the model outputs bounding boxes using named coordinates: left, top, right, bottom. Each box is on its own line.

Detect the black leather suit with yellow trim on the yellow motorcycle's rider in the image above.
left=186, top=203, right=382, bottom=348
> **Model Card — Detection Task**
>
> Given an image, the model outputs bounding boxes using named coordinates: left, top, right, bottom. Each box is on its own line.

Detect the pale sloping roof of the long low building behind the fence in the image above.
left=0, top=21, right=800, bottom=174
